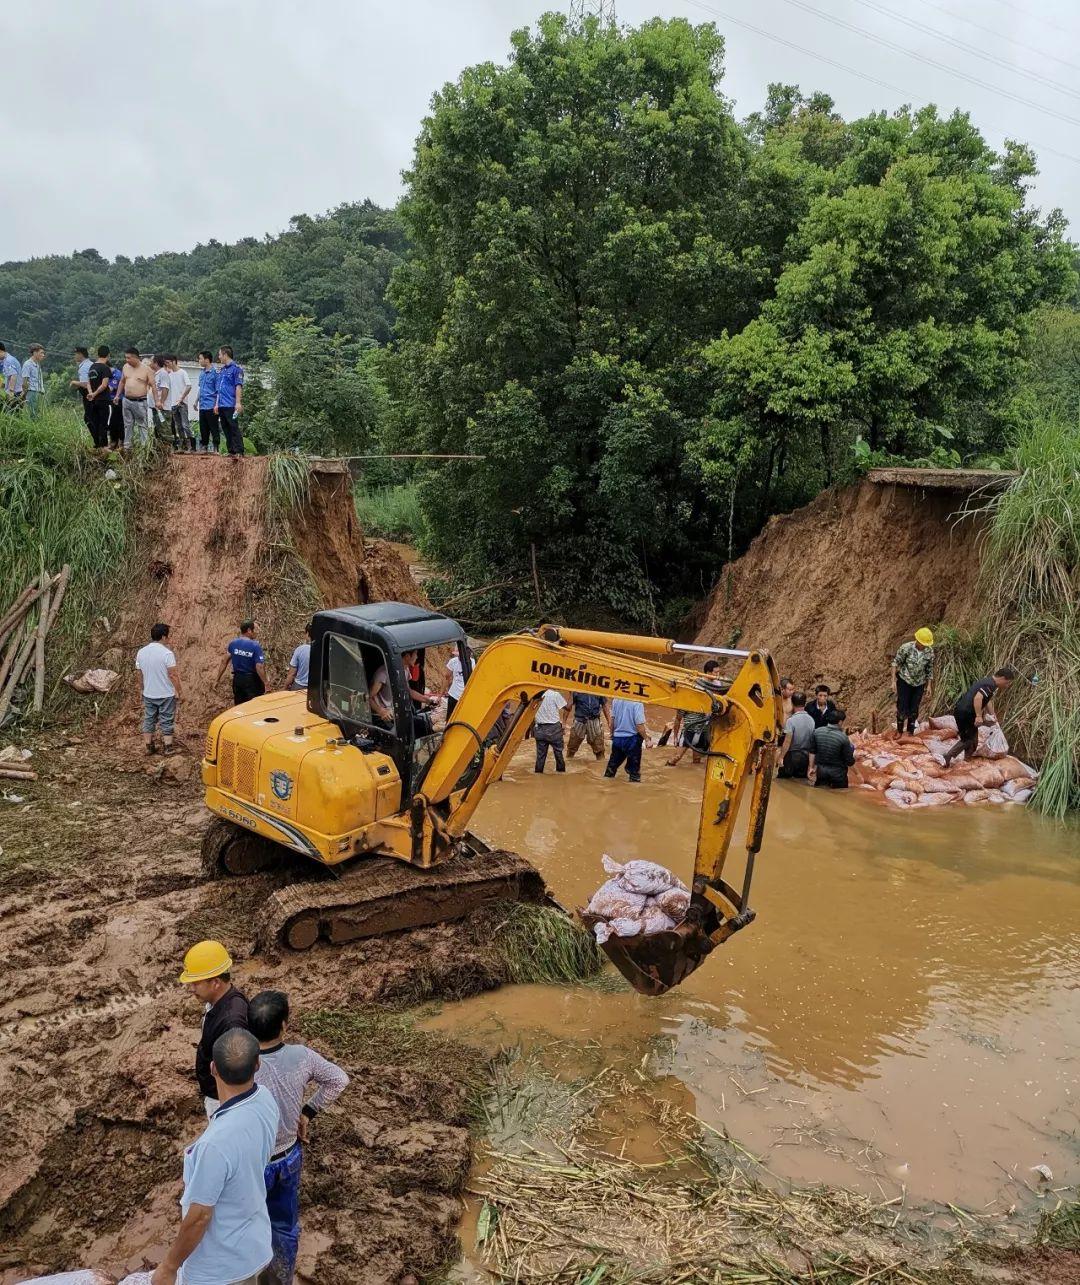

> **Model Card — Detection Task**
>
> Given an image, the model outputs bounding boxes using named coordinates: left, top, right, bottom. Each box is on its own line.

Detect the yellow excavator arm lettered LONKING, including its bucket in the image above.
left=401, top=626, right=780, bottom=995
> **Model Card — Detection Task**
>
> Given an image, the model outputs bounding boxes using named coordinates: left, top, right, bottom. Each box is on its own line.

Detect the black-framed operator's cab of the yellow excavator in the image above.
left=307, top=603, right=472, bottom=797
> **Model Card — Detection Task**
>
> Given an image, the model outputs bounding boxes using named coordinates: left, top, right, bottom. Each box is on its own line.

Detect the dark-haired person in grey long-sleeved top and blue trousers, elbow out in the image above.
left=248, top=991, right=348, bottom=1285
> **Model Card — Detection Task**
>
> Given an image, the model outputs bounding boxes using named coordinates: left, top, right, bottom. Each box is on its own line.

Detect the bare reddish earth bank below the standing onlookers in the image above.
left=105, top=455, right=422, bottom=739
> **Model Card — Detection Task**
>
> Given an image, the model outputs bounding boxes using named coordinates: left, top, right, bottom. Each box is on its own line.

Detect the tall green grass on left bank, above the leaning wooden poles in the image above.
left=0, top=405, right=145, bottom=719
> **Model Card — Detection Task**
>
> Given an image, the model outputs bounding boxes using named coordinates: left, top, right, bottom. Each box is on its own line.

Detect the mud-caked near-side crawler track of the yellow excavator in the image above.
left=255, top=844, right=546, bottom=951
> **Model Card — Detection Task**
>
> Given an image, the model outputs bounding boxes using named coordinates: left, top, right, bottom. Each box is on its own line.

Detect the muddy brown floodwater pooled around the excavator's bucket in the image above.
left=433, top=749, right=1080, bottom=1264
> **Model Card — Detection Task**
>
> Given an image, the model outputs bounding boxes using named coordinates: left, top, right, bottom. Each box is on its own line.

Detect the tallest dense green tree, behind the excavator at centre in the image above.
left=390, top=14, right=768, bottom=618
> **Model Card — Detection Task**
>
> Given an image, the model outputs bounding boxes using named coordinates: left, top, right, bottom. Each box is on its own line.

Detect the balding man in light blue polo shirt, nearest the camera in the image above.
left=150, top=1027, right=279, bottom=1285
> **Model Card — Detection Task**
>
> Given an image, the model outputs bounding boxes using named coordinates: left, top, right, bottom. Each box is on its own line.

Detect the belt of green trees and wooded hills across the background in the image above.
left=0, top=14, right=1080, bottom=623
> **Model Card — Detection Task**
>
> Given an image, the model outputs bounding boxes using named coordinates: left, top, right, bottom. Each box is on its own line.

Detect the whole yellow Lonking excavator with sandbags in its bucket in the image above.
left=202, top=603, right=780, bottom=995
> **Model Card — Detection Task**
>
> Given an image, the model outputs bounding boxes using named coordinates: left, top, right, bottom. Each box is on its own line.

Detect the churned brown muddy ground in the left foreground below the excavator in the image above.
left=0, top=738, right=509, bottom=1285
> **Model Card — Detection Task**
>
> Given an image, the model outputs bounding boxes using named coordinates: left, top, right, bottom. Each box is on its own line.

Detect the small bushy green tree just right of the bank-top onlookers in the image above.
left=249, top=316, right=386, bottom=455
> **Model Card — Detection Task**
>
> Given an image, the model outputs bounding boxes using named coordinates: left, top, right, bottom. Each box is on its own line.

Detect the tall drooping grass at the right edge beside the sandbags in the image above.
left=966, top=411, right=1080, bottom=817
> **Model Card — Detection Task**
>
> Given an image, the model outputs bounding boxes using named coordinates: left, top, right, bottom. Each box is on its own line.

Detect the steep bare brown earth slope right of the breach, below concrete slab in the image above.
left=697, top=482, right=980, bottom=721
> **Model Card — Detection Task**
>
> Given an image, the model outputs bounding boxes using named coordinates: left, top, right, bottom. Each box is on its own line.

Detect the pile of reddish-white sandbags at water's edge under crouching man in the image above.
left=849, top=714, right=1039, bottom=808
